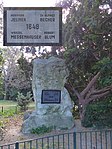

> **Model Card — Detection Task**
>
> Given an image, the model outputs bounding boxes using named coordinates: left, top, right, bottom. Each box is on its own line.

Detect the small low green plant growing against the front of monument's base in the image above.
left=31, top=125, right=53, bottom=135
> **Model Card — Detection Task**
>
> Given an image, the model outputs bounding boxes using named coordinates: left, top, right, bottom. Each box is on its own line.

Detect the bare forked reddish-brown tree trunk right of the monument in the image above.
left=71, top=72, right=112, bottom=124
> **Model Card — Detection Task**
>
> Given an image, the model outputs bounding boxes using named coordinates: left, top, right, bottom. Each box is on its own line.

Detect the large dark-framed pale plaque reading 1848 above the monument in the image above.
left=4, top=7, right=62, bottom=46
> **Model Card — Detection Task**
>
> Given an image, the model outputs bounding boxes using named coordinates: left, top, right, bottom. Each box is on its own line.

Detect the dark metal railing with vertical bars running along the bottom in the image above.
left=0, top=130, right=112, bottom=149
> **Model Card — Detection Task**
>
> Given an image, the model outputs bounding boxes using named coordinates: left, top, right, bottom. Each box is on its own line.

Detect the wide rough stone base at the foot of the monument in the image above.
left=22, top=112, right=74, bottom=133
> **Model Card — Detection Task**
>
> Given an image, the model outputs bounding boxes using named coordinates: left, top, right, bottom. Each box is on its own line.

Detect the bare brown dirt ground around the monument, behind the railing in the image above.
left=0, top=116, right=90, bottom=145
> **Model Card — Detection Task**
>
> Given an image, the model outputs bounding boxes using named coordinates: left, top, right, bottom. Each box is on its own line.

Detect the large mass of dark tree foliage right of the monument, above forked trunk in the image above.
left=58, top=0, right=112, bottom=124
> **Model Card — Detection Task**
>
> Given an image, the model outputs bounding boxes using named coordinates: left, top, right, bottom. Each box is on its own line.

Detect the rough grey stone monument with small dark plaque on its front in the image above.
left=22, top=57, right=74, bottom=133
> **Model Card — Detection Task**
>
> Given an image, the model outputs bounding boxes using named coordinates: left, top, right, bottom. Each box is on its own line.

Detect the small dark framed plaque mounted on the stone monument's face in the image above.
left=41, top=90, right=61, bottom=104
